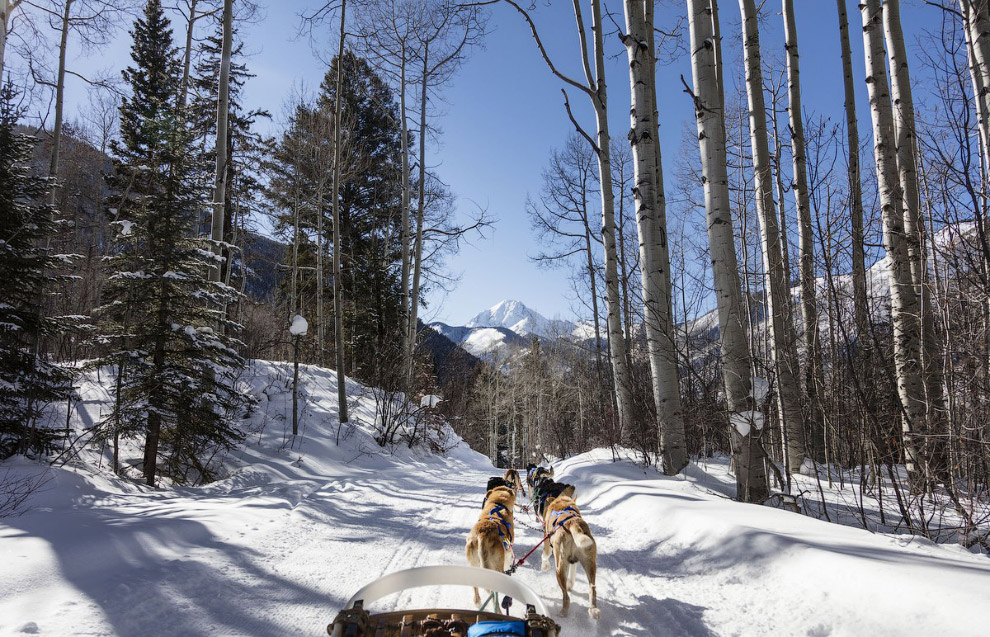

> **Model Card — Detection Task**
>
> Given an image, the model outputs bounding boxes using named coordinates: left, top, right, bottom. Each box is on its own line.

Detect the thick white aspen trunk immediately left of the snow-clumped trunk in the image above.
left=624, top=0, right=687, bottom=475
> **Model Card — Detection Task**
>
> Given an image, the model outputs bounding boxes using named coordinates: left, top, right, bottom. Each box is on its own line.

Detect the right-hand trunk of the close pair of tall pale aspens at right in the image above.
left=882, top=0, right=948, bottom=472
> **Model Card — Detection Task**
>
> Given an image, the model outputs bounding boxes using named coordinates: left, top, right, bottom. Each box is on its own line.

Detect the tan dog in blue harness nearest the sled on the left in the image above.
left=464, top=486, right=516, bottom=605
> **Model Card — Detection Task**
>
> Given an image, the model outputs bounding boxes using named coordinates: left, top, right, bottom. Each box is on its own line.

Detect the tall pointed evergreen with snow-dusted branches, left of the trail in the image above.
left=99, top=0, right=241, bottom=485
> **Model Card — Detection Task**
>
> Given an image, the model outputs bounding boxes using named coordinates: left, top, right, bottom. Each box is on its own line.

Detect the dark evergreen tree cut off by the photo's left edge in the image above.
left=0, top=83, right=71, bottom=459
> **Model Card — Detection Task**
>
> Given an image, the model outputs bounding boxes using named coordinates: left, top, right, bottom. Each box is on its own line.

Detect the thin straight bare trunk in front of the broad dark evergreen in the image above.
left=332, top=0, right=348, bottom=423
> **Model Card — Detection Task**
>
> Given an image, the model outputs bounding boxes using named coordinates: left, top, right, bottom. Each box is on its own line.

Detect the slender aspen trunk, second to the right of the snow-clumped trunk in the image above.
left=780, top=0, right=825, bottom=460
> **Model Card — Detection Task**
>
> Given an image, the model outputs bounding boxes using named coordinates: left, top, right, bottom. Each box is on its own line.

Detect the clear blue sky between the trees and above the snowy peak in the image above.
left=46, top=0, right=940, bottom=324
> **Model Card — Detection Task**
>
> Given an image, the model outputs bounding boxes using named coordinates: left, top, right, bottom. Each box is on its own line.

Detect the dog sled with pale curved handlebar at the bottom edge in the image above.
left=327, top=566, right=560, bottom=637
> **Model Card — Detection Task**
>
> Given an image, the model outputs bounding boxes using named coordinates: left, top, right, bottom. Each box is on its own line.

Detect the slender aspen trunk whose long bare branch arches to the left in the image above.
left=588, top=0, right=633, bottom=448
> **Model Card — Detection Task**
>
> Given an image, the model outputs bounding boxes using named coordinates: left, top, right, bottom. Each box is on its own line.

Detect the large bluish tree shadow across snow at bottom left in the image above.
left=5, top=508, right=345, bottom=635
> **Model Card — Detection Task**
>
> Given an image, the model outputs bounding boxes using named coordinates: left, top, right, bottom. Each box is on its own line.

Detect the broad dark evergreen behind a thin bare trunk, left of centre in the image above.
left=269, top=51, right=402, bottom=384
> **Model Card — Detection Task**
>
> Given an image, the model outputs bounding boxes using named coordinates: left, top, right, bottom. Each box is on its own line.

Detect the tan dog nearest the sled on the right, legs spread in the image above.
left=543, top=495, right=601, bottom=619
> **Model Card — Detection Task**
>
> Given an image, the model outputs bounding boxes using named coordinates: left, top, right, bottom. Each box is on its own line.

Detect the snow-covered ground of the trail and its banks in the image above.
left=0, top=363, right=990, bottom=637
